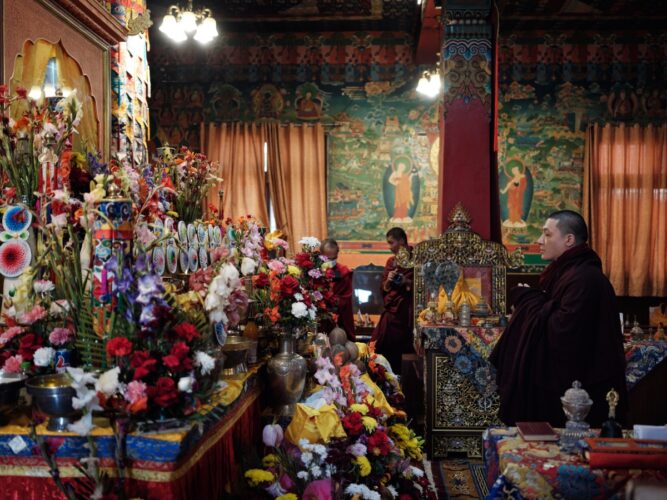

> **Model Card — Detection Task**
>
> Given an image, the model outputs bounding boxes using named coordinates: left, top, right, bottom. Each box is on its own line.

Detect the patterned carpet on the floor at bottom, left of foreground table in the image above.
left=431, top=460, right=489, bottom=500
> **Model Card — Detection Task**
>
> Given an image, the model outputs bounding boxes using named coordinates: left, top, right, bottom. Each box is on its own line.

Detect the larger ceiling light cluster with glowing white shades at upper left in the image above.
left=160, top=0, right=218, bottom=45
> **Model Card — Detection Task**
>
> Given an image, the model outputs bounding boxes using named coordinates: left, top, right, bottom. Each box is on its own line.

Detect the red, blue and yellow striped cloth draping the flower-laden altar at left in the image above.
left=0, top=366, right=261, bottom=500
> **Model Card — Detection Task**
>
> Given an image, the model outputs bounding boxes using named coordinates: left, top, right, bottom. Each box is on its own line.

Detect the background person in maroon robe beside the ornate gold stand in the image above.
left=371, top=227, right=414, bottom=374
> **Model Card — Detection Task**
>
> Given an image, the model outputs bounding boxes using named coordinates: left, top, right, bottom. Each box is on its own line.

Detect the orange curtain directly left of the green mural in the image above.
left=265, top=124, right=327, bottom=251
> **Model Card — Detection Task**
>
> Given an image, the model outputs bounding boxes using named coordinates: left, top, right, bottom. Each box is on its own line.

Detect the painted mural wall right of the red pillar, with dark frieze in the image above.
left=498, top=32, right=667, bottom=264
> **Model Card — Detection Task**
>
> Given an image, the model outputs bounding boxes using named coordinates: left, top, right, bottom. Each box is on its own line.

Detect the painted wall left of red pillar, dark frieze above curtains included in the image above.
left=150, top=31, right=439, bottom=252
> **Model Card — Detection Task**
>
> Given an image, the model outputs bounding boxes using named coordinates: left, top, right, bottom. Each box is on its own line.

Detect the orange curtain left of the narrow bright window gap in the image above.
left=201, top=123, right=269, bottom=227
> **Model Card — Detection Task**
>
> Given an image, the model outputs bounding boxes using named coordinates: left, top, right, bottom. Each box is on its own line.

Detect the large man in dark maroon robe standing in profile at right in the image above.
left=490, top=210, right=628, bottom=427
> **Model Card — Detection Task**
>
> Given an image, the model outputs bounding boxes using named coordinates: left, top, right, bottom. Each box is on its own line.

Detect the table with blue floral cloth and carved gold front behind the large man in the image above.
left=418, top=325, right=667, bottom=459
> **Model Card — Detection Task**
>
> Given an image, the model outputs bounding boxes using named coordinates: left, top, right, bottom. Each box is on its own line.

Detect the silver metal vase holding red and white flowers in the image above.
left=266, top=336, right=307, bottom=415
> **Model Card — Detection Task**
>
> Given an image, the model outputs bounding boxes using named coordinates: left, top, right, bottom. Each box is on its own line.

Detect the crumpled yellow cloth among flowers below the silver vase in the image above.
left=285, top=403, right=346, bottom=444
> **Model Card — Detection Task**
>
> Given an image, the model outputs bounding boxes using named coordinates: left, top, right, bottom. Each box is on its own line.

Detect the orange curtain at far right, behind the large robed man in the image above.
left=584, top=124, right=667, bottom=296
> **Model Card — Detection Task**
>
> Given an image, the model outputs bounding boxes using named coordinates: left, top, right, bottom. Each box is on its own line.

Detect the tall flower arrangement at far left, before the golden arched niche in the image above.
left=0, top=85, right=83, bottom=207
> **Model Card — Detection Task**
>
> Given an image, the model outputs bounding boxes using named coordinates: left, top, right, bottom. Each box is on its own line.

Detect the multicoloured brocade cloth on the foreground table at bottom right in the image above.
left=484, top=427, right=667, bottom=499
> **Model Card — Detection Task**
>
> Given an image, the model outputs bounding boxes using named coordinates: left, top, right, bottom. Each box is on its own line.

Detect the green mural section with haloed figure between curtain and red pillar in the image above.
left=327, top=94, right=440, bottom=246
